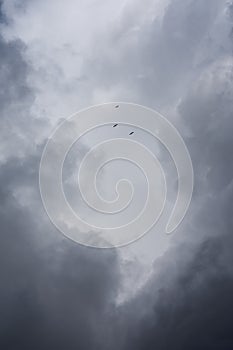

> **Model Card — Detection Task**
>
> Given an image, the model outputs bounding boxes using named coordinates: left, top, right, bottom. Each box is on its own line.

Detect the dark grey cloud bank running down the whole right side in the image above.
left=110, top=1, right=233, bottom=350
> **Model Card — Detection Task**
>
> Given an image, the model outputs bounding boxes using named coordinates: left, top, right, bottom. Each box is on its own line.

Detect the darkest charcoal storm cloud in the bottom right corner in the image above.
left=121, top=232, right=233, bottom=350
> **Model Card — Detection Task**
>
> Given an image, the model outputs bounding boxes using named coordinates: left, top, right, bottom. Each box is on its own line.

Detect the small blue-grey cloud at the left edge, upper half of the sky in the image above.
left=0, top=37, right=48, bottom=163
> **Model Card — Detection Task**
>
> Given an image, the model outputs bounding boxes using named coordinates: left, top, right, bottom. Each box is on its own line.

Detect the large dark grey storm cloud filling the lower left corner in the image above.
left=0, top=152, right=119, bottom=349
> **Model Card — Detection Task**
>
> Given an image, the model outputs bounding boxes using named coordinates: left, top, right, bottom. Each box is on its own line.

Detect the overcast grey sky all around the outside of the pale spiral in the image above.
left=0, top=0, right=233, bottom=350
